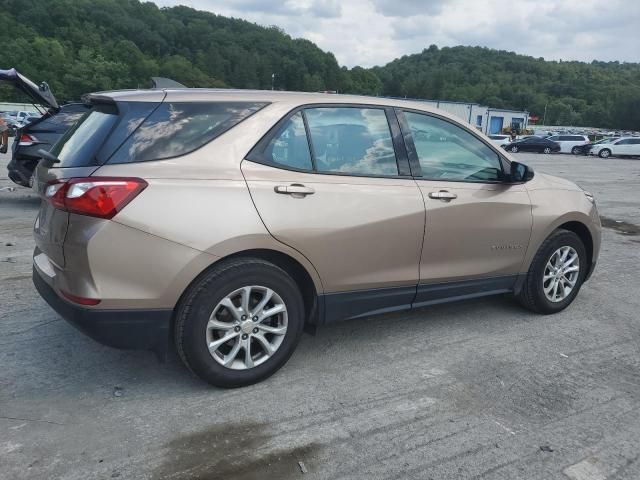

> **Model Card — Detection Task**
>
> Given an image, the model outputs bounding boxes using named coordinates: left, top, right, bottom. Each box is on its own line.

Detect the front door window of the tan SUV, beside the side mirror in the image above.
left=405, top=112, right=502, bottom=181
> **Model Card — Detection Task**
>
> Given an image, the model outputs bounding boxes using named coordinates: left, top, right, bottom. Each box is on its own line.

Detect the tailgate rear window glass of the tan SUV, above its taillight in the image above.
left=51, top=105, right=118, bottom=168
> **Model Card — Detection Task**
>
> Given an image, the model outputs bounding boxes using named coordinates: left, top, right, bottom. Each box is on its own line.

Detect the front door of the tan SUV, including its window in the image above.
left=400, top=111, right=532, bottom=305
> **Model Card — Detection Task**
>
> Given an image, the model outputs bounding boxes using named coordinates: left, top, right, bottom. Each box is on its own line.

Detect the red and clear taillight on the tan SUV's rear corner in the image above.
left=45, top=177, right=148, bottom=219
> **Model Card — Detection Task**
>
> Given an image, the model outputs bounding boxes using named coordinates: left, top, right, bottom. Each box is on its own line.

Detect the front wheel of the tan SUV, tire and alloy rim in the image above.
left=517, top=229, right=587, bottom=315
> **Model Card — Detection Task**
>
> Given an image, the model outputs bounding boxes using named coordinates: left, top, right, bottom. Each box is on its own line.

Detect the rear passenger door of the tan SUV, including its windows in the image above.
left=242, top=104, right=425, bottom=320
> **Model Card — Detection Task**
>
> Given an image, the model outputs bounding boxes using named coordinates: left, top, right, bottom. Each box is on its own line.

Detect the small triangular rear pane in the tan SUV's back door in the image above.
left=264, top=112, right=313, bottom=170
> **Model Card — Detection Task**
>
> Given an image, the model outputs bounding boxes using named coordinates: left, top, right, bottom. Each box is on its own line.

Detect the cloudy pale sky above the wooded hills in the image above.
left=154, top=0, right=640, bottom=67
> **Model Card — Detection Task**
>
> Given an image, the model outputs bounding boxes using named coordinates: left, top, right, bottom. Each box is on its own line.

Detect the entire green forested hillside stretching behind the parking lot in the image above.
left=0, top=0, right=640, bottom=129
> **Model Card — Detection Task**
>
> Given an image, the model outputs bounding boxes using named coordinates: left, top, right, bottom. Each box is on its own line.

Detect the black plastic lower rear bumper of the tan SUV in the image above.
left=33, top=268, right=172, bottom=355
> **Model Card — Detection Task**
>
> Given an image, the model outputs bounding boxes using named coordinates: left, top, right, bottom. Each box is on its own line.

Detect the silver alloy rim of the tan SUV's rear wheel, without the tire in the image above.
left=206, top=285, right=287, bottom=370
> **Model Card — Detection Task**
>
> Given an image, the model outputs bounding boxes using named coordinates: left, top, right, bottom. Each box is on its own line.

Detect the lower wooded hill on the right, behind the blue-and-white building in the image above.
left=373, top=45, right=640, bottom=130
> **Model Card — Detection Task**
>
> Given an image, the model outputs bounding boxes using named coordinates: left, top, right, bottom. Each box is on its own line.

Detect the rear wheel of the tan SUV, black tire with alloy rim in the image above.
left=175, top=258, right=305, bottom=388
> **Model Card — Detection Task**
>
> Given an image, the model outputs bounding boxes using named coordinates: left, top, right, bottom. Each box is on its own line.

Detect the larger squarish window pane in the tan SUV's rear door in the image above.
left=304, top=107, right=398, bottom=175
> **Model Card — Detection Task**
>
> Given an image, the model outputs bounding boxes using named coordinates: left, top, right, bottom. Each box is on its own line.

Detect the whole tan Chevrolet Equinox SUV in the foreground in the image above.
left=33, top=89, right=601, bottom=387
